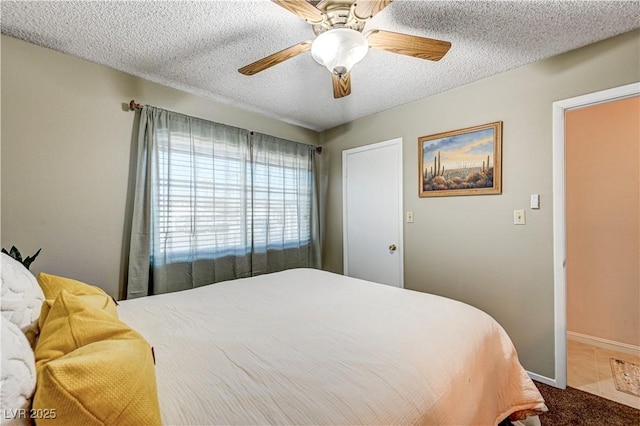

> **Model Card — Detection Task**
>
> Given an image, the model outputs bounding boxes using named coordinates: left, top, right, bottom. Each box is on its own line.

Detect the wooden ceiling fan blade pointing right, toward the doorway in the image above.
left=365, top=30, right=451, bottom=61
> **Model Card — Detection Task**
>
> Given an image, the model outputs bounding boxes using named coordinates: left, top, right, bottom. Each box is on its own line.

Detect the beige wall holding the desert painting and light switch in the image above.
left=323, top=31, right=640, bottom=378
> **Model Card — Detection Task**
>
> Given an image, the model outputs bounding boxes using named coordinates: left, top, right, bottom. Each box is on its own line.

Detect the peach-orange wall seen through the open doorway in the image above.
left=565, top=96, right=640, bottom=346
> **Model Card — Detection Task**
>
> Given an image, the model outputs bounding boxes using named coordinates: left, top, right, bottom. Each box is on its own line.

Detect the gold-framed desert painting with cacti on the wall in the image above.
left=418, top=121, right=502, bottom=197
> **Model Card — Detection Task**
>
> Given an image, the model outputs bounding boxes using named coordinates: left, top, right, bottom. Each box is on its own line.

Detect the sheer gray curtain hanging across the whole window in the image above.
left=127, top=106, right=320, bottom=298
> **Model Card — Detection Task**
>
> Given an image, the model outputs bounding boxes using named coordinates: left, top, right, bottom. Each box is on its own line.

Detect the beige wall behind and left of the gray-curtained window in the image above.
left=1, top=35, right=318, bottom=296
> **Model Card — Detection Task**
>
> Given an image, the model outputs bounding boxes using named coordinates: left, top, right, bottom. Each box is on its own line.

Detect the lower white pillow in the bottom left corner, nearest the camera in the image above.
left=0, top=315, right=36, bottom=425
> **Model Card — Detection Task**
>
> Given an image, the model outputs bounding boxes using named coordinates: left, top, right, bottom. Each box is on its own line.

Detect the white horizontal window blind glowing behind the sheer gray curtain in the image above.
left=152, top=129, right=313, bottom=263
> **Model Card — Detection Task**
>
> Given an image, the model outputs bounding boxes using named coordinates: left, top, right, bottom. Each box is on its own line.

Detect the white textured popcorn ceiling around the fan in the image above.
left=1, top=0, right=640, bottom=130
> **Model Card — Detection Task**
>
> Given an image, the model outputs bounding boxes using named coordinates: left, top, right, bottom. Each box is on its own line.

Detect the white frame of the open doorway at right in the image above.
left=551, top=82, right=640, bottom=389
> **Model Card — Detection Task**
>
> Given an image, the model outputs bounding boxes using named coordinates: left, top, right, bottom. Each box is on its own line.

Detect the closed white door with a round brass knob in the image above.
left=342, top=138, right=404, bottom=287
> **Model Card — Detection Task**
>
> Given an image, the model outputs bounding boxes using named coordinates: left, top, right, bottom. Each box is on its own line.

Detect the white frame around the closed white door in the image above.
left=342, top=137, right=404, bottom=288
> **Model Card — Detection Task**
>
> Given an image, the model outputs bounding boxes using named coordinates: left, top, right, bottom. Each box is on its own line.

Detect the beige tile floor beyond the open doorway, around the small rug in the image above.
left=567, top=339, right=640, bottom=409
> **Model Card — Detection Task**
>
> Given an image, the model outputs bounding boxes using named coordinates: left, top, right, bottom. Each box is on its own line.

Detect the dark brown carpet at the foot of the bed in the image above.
left=534, top=381, right=640, bottom=426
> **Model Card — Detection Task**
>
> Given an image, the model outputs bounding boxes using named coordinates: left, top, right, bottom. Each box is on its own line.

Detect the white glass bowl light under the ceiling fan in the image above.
left=311, top=28, right=369, bottom=76
